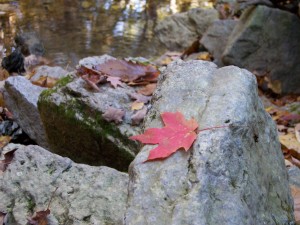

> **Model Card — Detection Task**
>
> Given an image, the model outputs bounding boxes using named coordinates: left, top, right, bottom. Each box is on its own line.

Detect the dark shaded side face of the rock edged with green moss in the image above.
left=38, top=85, right=139, bottom=171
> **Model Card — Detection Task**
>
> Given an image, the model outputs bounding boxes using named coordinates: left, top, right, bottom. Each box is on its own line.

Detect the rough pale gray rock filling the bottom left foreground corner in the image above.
left=0, top=145, right=128, bottom=225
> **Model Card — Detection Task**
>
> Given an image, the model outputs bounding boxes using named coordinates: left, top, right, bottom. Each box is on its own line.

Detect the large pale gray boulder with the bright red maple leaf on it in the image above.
left=125, top=61, right=294, bottom=225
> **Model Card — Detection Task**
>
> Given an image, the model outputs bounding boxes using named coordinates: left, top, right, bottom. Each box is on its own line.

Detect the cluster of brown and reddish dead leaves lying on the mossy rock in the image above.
left=77, top=59, right=160, bottom=125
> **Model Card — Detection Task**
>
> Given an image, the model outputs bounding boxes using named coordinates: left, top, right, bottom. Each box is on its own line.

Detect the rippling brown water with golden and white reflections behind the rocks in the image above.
left=0, top=0, right=212, bottom=65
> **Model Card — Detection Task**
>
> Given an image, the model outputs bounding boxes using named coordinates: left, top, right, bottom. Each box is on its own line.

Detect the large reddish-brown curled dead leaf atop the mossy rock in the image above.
left=95, top=59, right=159, bottom=82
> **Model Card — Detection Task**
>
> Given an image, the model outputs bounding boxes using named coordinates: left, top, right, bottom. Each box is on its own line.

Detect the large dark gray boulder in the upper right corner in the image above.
left=223, top=6, right=300, bottom=94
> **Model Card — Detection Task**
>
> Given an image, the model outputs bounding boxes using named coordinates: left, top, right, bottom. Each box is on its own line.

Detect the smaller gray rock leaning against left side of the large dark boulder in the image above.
left=200, top=20, right=237, bottom=66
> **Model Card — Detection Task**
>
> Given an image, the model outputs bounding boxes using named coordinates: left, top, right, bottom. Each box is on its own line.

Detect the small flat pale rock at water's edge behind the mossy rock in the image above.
left=30, top=66, right=69, bottom=81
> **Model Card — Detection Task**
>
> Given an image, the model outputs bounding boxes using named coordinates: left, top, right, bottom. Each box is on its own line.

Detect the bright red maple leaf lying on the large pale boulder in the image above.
left=130, top=112, right=198, bottom=161
